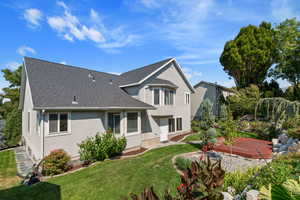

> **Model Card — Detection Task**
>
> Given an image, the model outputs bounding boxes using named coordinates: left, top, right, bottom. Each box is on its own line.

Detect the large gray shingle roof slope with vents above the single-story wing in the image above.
left=24, top=57, right=153, bottom=109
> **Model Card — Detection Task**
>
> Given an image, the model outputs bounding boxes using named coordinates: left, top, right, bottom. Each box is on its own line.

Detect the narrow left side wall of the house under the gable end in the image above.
left=22, top=78, right=42, bottom=160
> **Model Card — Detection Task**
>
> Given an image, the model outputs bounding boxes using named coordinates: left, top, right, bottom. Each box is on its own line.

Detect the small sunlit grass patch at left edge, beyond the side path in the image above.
left=0, top=150, right=19, bottom=189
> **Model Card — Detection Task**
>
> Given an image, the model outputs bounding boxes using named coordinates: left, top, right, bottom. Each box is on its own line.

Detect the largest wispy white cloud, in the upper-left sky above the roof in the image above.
left=47, top=1, right=138, bottom=51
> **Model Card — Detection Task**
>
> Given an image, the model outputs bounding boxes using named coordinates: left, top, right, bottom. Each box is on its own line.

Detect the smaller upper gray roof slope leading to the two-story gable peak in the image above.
left=121, top=58, right=173, bottom=85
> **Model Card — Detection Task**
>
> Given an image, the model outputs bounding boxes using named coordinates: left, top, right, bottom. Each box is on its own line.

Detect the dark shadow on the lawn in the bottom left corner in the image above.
left=0, top=182, right=61, bottom=200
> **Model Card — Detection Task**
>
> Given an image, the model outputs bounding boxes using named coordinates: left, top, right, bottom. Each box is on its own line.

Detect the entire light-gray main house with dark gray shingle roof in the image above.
left=19, top=57, right=194, bottom=160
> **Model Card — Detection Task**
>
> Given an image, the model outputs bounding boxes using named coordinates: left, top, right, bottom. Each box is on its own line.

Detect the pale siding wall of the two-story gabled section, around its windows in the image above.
left=125, top=64, right=191, bottom=140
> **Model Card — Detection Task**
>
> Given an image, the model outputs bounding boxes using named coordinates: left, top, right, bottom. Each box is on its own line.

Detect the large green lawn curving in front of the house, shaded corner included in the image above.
left=0, top=144, right=198, bottom=200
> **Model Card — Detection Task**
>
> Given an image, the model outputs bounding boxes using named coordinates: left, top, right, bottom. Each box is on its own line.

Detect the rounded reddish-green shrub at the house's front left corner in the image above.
left=42, top=149, right=70, bottom=176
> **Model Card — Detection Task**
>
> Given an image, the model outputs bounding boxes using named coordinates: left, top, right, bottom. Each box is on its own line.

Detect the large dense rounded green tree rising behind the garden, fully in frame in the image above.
left=220, top=22, right=276, bottom=88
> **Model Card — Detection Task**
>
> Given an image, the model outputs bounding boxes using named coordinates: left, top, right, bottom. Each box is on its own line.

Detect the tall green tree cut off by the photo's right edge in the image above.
left=270, top=18, right=300, bottom=100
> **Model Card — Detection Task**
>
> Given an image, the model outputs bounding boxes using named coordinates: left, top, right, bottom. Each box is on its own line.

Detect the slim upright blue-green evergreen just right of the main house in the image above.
left=199, top=99, right=215, bottom=130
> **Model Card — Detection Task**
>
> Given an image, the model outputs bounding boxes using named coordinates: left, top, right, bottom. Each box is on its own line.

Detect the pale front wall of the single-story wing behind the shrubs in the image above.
left=44, top=111, right=141, bottom=157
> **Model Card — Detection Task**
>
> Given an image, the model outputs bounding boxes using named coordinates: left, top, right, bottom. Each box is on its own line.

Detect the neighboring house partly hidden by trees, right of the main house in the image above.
left=192, top=81, right=235, bottom=119
